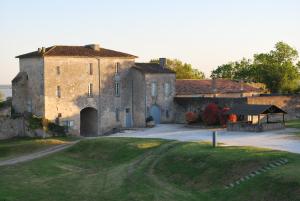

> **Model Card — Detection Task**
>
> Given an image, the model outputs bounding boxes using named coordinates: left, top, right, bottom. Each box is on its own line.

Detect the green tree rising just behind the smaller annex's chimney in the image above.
left=150, top=59, right=205, bottom=79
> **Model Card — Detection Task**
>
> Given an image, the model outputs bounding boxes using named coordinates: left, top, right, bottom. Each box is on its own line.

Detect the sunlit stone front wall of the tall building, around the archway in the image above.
left=45, top=57, right=134, bottom=135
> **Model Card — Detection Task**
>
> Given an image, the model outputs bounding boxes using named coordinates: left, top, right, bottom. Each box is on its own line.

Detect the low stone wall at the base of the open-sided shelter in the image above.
left=227, top=122, right=285, bottom=132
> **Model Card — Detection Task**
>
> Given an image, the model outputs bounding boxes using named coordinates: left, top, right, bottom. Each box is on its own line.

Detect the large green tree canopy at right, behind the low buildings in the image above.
left=211, top=42, right=300, bottom=92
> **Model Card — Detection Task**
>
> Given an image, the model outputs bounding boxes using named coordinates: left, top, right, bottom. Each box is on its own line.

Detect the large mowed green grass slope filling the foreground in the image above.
left=0, top=138, right=300, bottom=201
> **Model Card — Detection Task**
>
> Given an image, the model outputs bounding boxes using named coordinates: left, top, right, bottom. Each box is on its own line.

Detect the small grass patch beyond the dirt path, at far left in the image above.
left=0, top=138, right=78, bottom=160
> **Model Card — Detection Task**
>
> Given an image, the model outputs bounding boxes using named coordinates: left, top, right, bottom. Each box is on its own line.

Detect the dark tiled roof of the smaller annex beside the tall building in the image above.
left=134, top=63, right=175, bottom=74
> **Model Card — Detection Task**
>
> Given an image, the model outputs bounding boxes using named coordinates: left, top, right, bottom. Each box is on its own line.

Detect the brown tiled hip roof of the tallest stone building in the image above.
left=16, top=46, right=136, bottom=58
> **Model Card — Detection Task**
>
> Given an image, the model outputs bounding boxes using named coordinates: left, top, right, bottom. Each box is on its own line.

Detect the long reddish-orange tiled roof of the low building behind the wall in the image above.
left=176, top=79, right=261, bottom=95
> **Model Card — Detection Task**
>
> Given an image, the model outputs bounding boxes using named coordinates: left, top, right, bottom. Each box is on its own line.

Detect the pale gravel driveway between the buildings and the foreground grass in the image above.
left=109, top=124, right=300, bottom=153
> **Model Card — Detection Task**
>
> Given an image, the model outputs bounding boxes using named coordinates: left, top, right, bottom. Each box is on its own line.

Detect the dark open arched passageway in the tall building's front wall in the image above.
left=80, top=107, right=98, bottom=136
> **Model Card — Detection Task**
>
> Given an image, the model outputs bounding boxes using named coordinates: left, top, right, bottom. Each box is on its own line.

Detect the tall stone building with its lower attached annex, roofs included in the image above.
left=12, top=44, right=175, bottom=136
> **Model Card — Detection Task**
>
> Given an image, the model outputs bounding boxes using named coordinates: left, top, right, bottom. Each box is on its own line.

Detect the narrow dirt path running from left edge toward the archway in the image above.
left=0, top=140, right=79, bottom=166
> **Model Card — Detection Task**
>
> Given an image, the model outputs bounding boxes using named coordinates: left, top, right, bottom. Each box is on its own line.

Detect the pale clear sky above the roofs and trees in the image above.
left=0, top=0, right=300, bottom=84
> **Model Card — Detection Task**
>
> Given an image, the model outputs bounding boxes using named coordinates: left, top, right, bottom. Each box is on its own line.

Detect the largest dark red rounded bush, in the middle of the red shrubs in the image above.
left=202, top=103, right=220, bottom=125
